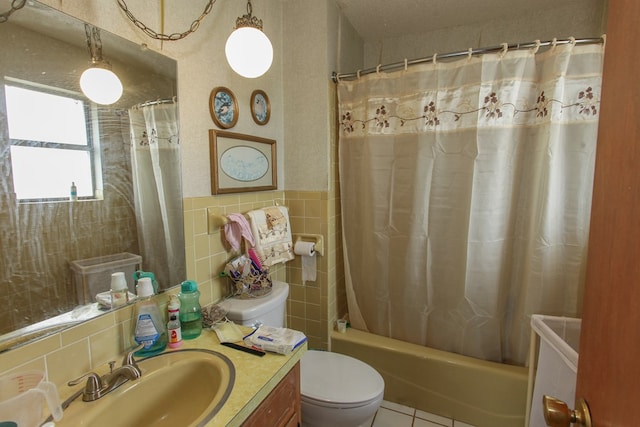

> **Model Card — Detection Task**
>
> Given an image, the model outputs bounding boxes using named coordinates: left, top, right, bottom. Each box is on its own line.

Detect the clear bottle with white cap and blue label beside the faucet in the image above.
left=132, top=277, right=167, bottom=357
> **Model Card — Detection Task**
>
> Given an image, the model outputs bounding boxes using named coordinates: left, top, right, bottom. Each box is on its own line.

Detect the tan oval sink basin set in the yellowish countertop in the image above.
left=56, top=349, right=235, bottom=427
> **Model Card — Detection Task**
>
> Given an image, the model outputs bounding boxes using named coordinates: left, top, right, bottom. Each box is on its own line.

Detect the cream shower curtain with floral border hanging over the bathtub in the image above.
left=338, top=44, right=604, bottom=365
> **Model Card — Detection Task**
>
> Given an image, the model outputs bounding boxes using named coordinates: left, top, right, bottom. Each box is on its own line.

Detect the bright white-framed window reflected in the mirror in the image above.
left=4, top=80, right=95, bottom=201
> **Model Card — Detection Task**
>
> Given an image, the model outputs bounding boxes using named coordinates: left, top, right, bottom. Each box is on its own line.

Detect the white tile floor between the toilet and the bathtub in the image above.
left=371, top=400, right=474, bottom=427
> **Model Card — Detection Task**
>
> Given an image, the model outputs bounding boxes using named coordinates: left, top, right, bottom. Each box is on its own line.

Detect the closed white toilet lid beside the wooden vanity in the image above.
left=300, top=350, right=384, bottom=404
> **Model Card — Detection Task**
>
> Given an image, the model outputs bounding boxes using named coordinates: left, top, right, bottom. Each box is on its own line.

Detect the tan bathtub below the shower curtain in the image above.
left=331, top=329, right=528, bottom=427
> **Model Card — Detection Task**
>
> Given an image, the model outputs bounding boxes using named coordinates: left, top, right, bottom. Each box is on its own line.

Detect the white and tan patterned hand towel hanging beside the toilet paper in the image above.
left=247, top=206, right=295, bottom=266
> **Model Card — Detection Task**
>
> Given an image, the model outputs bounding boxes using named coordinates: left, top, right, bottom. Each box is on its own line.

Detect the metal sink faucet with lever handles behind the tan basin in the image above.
left=67, top=345, right=142, bottom=406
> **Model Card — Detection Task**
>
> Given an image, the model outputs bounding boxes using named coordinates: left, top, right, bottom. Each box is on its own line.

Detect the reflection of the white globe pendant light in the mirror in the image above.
left=80, top=24, right=122, bottom=105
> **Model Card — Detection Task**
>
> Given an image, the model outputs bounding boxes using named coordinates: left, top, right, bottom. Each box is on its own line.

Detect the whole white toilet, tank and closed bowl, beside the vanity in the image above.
left=219, top=281, right=384, bottom=427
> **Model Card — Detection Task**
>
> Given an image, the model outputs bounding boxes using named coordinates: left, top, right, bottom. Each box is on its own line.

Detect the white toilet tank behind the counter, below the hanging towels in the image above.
left=218, top=280, right=289, bottom=327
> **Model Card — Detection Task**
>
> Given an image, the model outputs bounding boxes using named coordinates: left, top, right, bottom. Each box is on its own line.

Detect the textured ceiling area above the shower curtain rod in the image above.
left=336, top=0, right=583, bottom=42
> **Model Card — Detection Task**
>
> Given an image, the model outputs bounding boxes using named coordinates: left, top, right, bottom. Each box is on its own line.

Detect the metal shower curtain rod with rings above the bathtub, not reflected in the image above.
left=331, top=35, right=605, bottom=83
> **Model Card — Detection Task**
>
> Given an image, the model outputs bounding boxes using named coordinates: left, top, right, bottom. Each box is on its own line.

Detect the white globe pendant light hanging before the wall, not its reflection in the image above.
left=224, top=0, right=273, bottom=78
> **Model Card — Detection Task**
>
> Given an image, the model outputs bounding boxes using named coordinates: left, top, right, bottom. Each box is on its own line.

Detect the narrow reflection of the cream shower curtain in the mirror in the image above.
left=129, top=102, right=186, bottom=289
